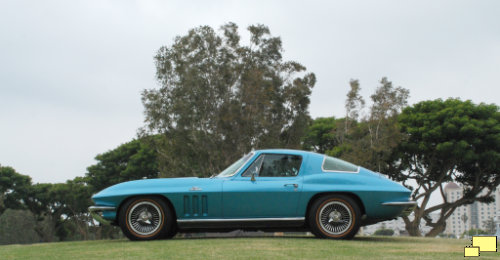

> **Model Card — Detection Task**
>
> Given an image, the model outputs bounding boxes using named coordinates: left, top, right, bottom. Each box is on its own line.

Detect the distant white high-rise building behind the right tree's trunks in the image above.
left=444, top=182, right=500, bottom=237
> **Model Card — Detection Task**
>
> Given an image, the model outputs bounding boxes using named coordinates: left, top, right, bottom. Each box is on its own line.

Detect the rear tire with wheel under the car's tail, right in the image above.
left=308, top=195, right=361, bottom=239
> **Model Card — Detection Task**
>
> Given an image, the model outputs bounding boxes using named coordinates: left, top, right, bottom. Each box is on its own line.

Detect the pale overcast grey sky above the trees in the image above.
left=0, top=0, right=500, bottom=185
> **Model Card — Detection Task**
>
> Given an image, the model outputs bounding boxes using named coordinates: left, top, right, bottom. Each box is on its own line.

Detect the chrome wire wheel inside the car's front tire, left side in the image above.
left=127, top=200, right=163, bottom=236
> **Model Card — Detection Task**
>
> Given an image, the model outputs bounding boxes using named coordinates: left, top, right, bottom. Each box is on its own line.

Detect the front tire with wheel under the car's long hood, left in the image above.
left=118, top=197, right=175, bottom=240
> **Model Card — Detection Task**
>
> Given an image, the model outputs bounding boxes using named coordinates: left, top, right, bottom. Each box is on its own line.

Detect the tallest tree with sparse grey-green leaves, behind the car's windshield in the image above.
left=141, top=23, right=316, bottom=176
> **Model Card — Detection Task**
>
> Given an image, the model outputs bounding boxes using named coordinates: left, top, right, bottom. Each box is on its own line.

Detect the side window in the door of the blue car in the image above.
left=258, top=154, right=302, bottom=177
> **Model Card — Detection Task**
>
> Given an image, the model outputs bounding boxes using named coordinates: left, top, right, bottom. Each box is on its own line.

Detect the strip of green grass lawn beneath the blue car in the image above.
left=0, top=237, right=500, bottom=260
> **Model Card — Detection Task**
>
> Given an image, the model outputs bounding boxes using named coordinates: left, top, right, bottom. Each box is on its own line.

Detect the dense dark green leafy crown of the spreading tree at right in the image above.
left=395, top=99, right=500, bottom=188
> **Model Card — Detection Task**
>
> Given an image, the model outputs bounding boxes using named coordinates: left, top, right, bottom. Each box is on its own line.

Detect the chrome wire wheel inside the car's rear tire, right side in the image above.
left=318, top=201, right=353, bottom=236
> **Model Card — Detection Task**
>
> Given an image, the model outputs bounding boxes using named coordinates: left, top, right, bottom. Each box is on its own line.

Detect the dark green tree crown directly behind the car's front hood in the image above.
left=85, top=137, right=159, bottom=192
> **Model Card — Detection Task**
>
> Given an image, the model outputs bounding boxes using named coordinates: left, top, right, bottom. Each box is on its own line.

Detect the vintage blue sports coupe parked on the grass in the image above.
left=89, top=149, right=416, bottom=240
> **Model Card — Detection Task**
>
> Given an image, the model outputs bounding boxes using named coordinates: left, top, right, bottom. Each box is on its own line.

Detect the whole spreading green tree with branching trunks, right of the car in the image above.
left=387, top=99, right=500, bottom=236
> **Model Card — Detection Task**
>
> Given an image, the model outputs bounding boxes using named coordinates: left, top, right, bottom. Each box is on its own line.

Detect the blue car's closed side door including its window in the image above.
left=222, top=154, right=304, bottom=218
